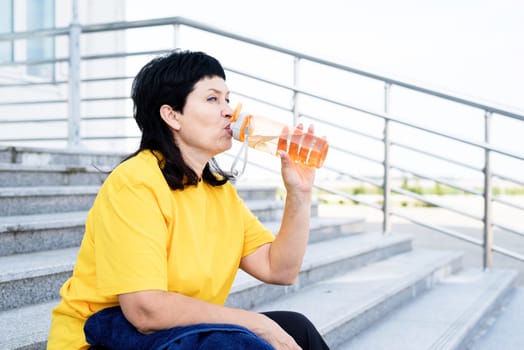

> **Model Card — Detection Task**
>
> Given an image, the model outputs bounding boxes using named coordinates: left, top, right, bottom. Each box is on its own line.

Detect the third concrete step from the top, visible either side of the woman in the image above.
left=0, top=185, right=286, bottom=217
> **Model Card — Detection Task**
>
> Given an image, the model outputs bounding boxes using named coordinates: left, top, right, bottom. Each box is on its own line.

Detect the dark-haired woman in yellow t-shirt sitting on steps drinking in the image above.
left=48, top=51, right=327, bottom=349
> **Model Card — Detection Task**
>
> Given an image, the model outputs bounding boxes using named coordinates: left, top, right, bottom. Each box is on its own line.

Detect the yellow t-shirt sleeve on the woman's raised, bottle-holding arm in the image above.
left=240, top=200, right=275, bottom=257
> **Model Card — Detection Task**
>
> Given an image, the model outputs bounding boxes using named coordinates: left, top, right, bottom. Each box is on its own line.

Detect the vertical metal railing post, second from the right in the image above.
left=382, top=83, right=391, bottom=234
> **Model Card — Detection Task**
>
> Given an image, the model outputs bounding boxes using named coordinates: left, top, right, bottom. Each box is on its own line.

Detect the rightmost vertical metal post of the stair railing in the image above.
left=483, top=111, right=493, bottom=270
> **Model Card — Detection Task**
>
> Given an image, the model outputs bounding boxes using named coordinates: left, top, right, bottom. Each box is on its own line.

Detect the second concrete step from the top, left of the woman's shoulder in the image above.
left=0, top=163, right=112, bottom=187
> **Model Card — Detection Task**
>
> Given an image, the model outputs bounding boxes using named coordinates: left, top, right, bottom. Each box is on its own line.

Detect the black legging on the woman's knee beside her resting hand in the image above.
left=263, top=311, right=329, bottom=350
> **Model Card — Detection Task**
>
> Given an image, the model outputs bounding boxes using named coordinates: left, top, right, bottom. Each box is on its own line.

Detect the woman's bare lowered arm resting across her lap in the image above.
left=118, top=290, right=299, bottom=349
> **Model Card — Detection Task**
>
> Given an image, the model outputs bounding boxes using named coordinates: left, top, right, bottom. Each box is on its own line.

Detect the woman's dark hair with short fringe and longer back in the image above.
left=131, top=50, right=229, bottom=189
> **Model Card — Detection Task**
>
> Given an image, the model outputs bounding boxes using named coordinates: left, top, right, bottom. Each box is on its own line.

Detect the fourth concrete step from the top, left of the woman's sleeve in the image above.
left=0, top=211, right=87, bottom=256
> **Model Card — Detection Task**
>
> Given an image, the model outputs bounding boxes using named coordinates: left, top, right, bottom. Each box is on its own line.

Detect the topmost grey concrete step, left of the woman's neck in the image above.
left=0, top=146, right=126, bottom=168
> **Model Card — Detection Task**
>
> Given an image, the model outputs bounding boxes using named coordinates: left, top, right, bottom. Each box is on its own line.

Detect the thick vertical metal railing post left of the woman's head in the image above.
left=68, top=0, right=82, bottom=147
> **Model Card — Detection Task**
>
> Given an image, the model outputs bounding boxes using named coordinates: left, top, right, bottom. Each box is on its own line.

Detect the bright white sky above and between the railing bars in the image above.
left=121, top=0, right=524, bottom=179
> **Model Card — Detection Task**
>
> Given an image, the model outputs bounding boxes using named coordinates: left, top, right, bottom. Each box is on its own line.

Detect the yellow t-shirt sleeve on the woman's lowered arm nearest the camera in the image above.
left=93, top=180, right=168, bottom=295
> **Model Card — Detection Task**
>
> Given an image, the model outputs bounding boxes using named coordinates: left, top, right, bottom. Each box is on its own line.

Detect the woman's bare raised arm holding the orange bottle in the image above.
left=240, top=125, right=315, bottom=284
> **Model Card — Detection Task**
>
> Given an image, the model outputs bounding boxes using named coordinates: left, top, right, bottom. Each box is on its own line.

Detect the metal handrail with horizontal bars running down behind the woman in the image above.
left=0, top=17, right=524, bottom=268
